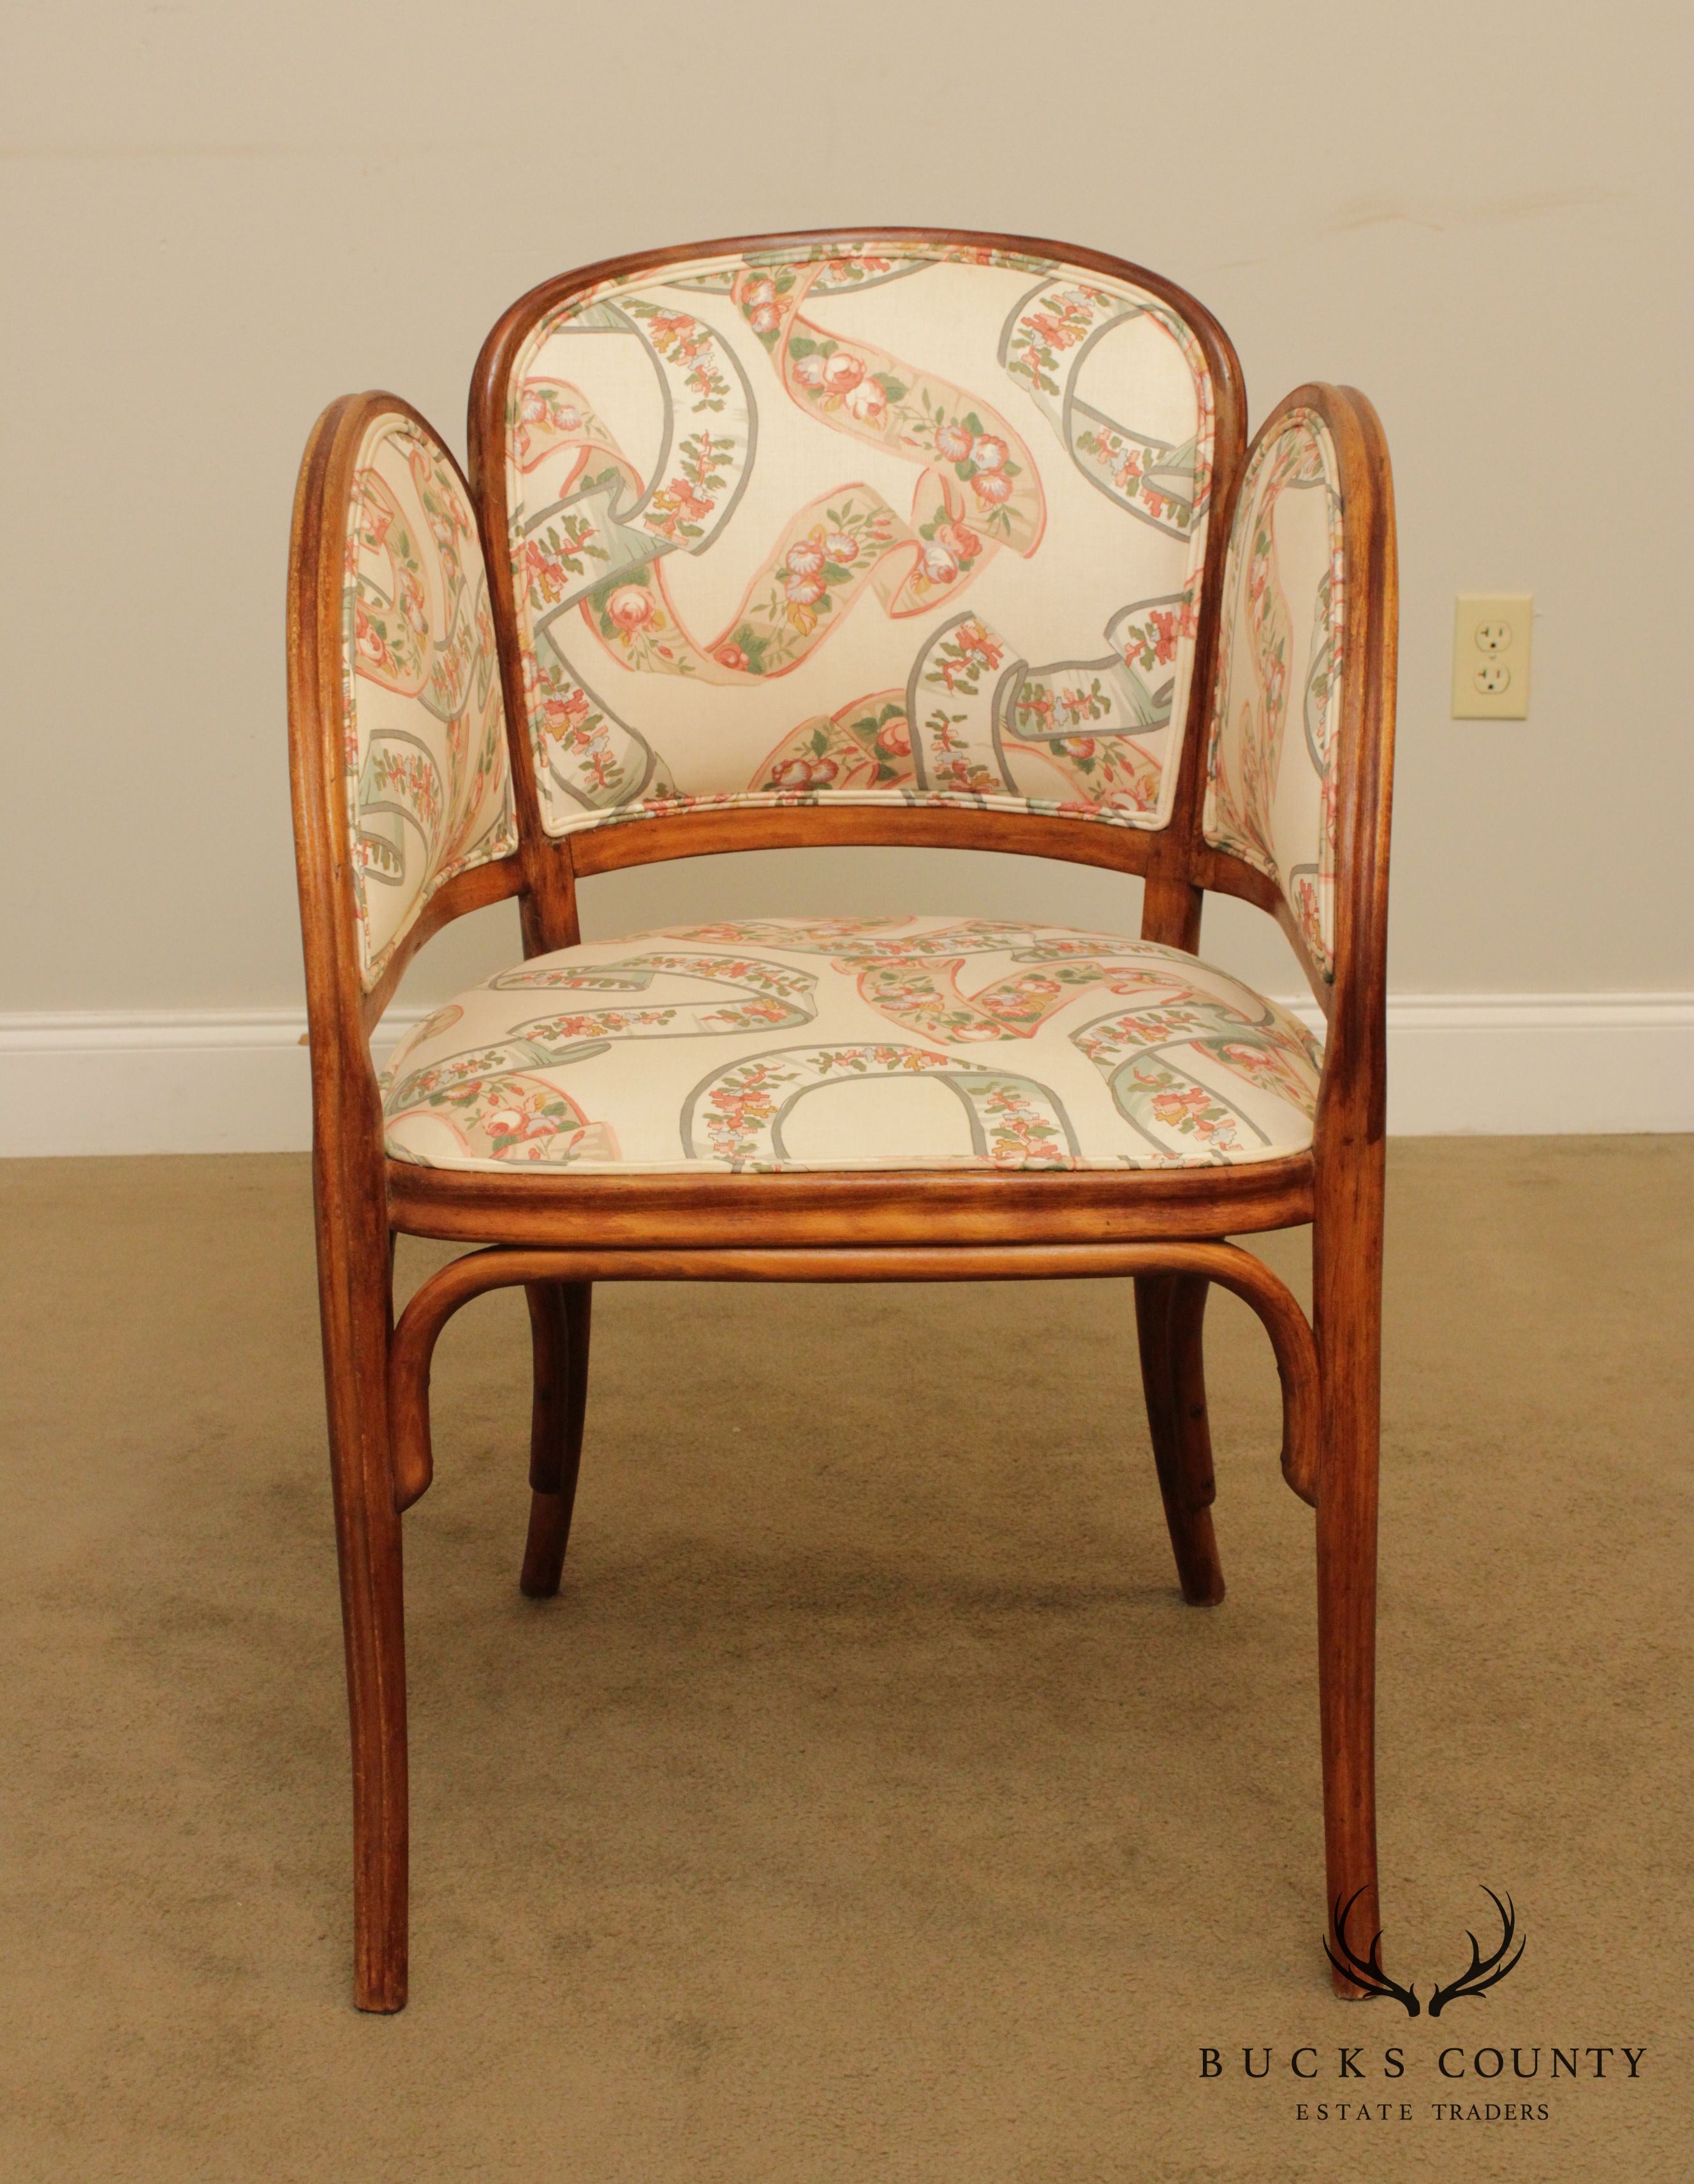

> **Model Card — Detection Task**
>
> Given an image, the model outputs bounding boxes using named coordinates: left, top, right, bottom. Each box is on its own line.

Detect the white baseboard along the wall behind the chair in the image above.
left=0, top=993, right=1694, bottom=1157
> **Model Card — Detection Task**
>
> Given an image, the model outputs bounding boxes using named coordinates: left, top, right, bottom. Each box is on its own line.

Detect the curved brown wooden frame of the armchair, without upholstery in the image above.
left=288, top=230, right=1397, bottom=2009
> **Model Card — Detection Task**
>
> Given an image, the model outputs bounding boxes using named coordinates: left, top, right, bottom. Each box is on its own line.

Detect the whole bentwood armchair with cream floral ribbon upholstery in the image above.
left=288, top=230, right=1394, bottom=2009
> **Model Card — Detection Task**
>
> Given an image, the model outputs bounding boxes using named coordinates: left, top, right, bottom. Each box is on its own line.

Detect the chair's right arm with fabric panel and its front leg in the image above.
left=1204, top=386, right=1399, bottom=1994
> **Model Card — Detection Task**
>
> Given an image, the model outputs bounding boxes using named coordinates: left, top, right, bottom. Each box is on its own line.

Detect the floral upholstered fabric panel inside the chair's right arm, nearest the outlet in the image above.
left=1204, top=408, right=1346, bottom=978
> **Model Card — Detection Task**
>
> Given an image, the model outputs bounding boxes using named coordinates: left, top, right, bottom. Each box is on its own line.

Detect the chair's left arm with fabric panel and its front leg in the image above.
left=288, top=395, right=529, bottom=2009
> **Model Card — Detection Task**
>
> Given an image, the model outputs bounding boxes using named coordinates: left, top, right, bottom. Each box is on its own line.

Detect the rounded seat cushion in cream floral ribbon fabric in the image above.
left=383, top=918, right=1318, bottom=1175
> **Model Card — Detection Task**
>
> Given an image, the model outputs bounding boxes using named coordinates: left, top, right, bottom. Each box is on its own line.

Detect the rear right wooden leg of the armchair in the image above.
left=1135, top=1273, right=1224, bottom=1608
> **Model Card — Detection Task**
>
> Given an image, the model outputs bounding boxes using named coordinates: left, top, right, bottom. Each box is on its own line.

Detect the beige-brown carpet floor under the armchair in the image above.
left=0, top=1138, right=1694, bottom=2184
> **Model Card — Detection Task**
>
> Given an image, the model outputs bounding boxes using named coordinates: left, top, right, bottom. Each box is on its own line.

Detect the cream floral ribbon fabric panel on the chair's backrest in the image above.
left=507, top=242, right=1213, bottom=834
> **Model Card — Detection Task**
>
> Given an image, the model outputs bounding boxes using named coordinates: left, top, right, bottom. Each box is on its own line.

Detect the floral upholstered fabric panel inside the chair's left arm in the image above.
left=341, top=411, right=518, bottom=990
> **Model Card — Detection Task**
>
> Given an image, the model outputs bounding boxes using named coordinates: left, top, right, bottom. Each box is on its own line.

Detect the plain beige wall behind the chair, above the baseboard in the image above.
left=0, top=0, right=1694, bottom=1009
